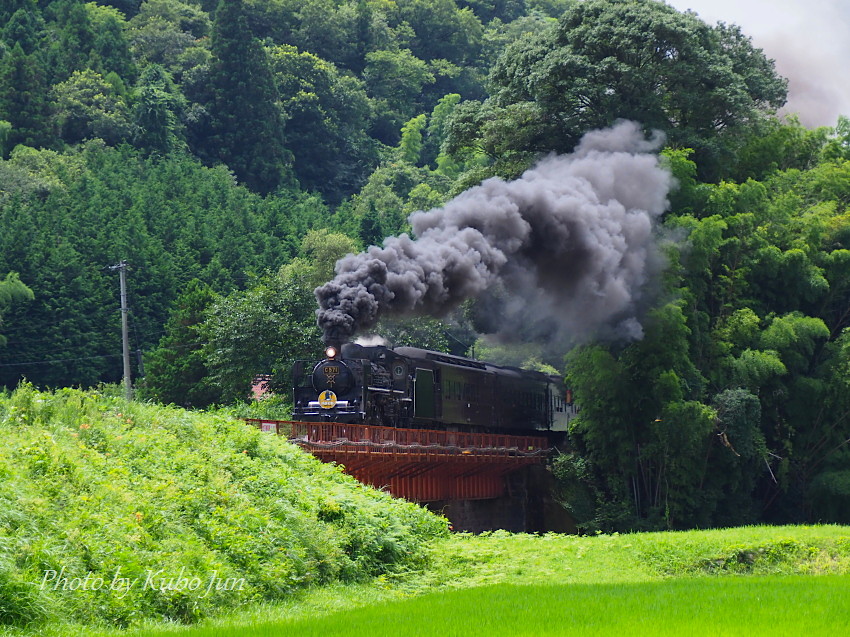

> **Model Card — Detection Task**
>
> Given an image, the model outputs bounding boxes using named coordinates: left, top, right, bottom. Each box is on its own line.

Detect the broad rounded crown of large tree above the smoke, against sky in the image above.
left=448, top=0, right=786, bottom=176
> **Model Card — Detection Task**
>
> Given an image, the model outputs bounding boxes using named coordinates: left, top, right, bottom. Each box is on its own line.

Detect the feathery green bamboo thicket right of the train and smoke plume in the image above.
left=568, top=132, right=850, bottom=528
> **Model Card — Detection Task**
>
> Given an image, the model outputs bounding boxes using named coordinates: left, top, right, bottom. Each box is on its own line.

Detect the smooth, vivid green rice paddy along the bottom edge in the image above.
left=174, top=576, right=850, bottom=637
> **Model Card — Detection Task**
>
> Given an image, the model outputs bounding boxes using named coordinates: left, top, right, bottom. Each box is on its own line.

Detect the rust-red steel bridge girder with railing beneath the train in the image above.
left=247, top=419, right=549, bottom=502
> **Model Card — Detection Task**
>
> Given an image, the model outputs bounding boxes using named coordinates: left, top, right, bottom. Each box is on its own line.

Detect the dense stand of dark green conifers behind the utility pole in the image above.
left=0, top=143, right=326, bottom=387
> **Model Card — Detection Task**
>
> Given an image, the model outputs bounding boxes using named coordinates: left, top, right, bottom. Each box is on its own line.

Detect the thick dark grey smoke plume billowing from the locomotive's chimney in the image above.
left=316, top=122, right=672, bottom=343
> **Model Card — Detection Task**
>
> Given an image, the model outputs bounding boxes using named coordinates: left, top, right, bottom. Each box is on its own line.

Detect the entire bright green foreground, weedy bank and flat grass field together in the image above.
left=0, top=387, right=850, bottom=637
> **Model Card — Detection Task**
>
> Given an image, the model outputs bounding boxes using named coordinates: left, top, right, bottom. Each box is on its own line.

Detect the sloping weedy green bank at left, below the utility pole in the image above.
left=0, top=386, right=446, bottom=627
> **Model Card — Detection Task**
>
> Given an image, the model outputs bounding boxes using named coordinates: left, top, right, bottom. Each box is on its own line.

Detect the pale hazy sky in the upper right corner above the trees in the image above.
left=666, top=0, right=850, bottom=126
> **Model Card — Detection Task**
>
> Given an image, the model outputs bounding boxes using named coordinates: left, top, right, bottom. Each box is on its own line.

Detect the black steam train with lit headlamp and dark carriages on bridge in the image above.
left=293, top=343, right=577, bottom=434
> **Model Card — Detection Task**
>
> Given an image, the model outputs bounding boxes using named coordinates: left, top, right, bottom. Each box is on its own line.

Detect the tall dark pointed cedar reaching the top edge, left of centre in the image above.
left=209, top=0, right=288, bottom=194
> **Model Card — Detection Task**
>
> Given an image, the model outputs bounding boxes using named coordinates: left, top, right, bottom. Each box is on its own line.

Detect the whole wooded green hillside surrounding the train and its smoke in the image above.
left=0, top=0, right=850, bottom=532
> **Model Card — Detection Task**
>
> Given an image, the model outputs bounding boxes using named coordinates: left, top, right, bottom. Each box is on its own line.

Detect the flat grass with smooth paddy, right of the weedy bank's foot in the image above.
left=8, top=526, right=850, bottom=637
